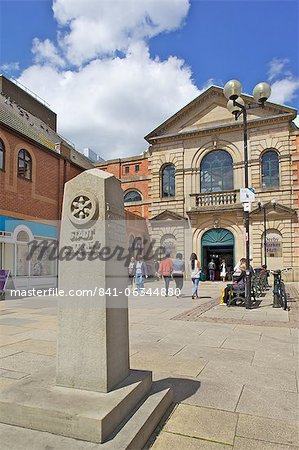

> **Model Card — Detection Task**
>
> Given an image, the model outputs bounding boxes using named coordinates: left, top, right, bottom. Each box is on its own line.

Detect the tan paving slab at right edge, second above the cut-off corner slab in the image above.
left=236, top=386, right=298, bottom=422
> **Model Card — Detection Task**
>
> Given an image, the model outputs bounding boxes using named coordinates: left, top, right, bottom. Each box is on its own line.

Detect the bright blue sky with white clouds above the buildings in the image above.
left=0, top=0, right=299, bottom=159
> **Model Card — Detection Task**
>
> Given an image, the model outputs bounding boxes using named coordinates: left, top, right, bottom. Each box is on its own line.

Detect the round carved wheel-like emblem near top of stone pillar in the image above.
left=68, top=191, right=97, bottom=225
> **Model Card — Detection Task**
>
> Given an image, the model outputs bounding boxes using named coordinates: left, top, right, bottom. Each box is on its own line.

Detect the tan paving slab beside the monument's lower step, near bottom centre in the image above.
left=164, top=404, right=238, bottom=445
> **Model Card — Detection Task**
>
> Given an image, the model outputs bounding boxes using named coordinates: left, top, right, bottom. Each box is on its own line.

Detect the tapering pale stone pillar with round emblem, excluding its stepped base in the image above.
left=56, top=169, right=129, bottom=392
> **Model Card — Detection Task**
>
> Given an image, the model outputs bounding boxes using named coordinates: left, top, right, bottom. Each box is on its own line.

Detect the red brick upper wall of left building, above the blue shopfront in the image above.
left=0, top=129, right=85, bottom=220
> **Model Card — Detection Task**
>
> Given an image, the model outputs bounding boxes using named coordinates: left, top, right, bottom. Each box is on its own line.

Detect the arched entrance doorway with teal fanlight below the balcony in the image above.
left=201, top=228, right=235, bottom=280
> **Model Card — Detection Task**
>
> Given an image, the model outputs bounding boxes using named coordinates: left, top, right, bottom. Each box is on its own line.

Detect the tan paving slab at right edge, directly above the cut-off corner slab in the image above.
left=236, top=414, right=299, bottom=446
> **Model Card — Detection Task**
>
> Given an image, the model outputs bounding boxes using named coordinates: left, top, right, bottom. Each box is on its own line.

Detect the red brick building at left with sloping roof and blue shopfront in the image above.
left=0, top=76, right=93, bottom=288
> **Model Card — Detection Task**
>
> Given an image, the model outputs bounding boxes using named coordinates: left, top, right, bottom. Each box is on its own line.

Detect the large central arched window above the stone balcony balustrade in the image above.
left=200, top=150, right=234, bottom=192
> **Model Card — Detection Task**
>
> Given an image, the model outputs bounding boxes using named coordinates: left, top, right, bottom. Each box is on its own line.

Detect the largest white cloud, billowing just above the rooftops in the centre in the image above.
left=19, top=42, right=199, bottom=159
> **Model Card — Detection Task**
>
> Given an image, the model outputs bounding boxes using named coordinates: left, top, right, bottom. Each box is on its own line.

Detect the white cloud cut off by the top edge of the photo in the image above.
left=53, top=0, right=190, bottom=66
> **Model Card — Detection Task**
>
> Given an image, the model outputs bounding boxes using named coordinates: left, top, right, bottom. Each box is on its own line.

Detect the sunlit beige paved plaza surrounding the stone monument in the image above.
left=0, top=281, right=298, bottom=450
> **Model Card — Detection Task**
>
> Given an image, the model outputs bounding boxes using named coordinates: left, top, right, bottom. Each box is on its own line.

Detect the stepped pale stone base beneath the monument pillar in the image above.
left=0, top=367, right=172, bottom=450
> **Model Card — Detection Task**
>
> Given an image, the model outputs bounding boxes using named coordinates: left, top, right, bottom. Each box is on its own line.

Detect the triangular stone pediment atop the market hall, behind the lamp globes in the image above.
left=145, top=86, right=296, bottom=142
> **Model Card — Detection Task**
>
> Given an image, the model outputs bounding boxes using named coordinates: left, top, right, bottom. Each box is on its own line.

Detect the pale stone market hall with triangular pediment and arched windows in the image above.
left=97, top=86, right=299, bottom=280
